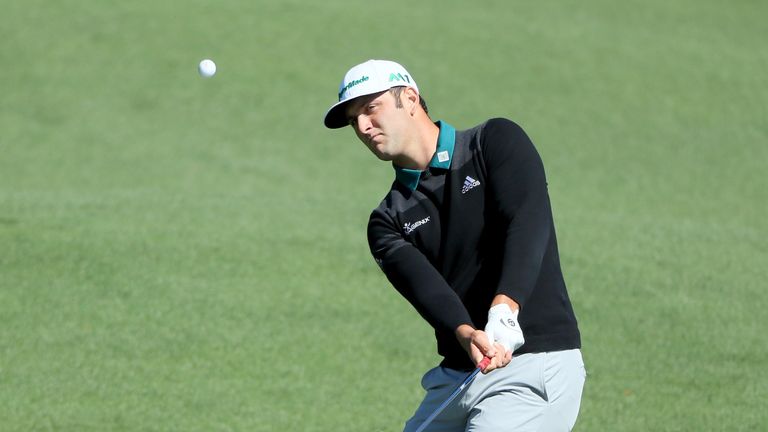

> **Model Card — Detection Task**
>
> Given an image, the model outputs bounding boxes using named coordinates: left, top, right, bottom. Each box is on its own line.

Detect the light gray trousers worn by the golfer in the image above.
left=404, top=349, right=586, bottom=432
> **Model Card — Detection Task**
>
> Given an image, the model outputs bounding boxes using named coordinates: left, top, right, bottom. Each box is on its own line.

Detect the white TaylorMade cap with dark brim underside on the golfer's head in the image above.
left=325, top=60, right=419, bottom=129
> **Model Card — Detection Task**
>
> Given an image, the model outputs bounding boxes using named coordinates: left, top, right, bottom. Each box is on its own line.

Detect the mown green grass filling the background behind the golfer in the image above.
left=0, top=0, right=768, bottom=431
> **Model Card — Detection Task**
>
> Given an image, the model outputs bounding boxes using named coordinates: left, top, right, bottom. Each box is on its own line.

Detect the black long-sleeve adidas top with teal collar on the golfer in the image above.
left=368, top=119, right=581, bottom=370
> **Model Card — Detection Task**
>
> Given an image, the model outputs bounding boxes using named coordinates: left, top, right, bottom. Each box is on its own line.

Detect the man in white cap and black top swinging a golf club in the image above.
left=325, top=60, right=586, bottom=432
